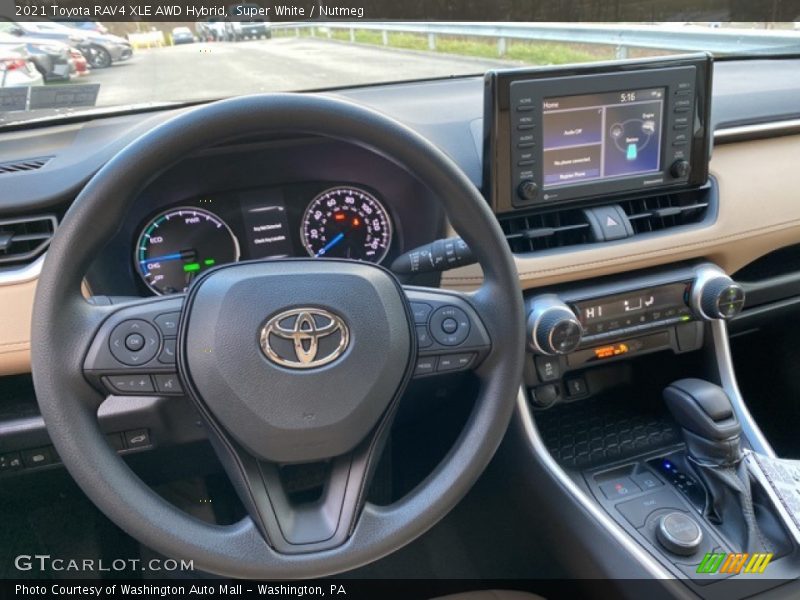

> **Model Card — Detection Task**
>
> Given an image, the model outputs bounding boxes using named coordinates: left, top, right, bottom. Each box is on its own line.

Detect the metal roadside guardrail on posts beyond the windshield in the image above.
left=272, top=21, right=800, bottom=58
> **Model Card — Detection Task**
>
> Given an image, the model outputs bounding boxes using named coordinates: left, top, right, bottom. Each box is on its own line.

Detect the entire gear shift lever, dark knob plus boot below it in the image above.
left=664, top=379, right=771, bottom=552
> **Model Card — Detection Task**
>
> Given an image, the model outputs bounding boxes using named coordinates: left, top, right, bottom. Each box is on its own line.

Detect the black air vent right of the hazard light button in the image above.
left=618, top=193, right=708, bottom=235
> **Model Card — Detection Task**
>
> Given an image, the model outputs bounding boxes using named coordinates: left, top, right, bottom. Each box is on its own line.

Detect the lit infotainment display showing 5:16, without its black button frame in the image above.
left=542, top=87, right=665, bottom=189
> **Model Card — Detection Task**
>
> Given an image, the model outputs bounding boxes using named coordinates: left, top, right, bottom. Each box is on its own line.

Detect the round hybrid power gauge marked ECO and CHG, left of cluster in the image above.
left=135, top=206, right=239, bottom=294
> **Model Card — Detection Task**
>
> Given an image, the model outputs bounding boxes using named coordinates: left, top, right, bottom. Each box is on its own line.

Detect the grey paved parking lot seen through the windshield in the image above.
left=87, top=38, right=514, bottom=105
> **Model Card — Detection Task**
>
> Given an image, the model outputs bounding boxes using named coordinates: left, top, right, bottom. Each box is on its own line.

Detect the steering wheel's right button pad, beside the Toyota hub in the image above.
left=403, top=286, right=492, bottom=378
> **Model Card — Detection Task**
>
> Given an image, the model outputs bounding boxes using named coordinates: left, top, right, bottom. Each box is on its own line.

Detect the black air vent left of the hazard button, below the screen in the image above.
left=500, top=209, right=591, bottom=253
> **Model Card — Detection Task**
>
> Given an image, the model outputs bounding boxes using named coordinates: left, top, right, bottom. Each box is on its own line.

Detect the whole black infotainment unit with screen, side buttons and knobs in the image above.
left=483, top=54, right=712, bottom=213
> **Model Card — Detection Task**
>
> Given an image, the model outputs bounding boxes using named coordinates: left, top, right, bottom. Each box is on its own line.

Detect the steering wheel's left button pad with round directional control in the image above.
left=83, top=296, right=184, bottom=396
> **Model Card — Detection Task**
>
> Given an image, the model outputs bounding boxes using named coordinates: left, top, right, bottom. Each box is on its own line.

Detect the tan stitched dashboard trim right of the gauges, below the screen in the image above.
left=442, top=135, right=800, bottom=289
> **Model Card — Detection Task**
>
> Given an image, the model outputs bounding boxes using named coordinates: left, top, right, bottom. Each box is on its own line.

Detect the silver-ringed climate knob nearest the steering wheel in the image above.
left=528, top=296, right=583, bottom=355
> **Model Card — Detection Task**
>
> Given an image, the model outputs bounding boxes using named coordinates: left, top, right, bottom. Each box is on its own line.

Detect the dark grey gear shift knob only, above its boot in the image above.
left=664, top=379, right=742, bottom=465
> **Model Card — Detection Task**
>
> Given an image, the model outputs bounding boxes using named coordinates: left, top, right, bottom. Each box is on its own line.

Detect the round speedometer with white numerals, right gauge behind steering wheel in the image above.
left=301, top=187, right=392, bottom=263
